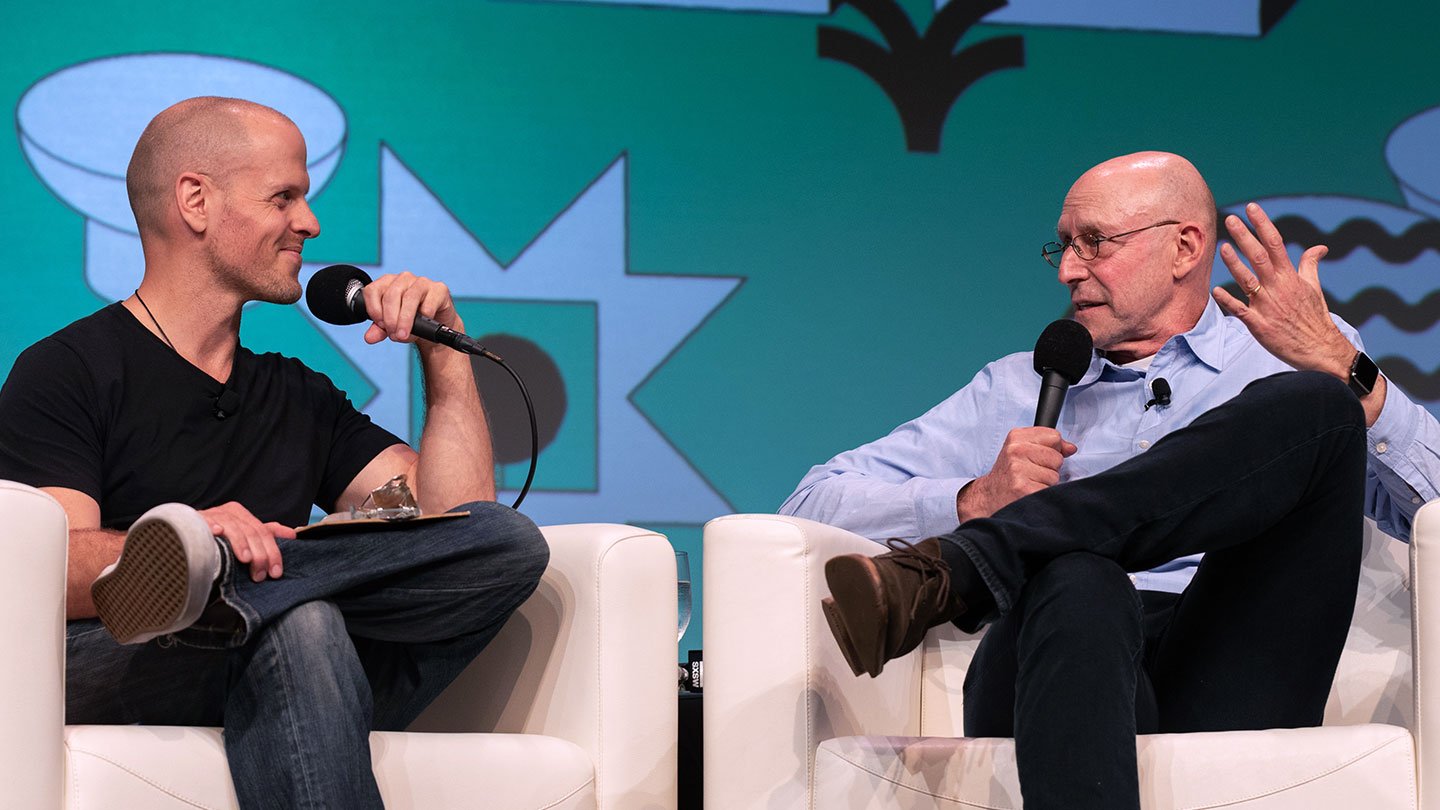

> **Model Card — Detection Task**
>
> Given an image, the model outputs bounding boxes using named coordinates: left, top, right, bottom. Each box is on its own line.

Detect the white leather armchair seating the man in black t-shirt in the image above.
left=0, top=481, right=677, bottom=810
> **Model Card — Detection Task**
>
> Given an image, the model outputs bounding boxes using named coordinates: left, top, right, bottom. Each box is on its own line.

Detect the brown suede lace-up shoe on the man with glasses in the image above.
left=821, top=538, right=965, bottom=677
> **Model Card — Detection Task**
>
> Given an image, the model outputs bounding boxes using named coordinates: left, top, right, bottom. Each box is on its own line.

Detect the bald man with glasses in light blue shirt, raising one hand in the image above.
left=780, top=153, right=1440, bottom=810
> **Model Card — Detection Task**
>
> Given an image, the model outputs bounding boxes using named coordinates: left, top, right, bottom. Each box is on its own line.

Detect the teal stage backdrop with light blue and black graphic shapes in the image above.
left=0, top=0, right=1440, bottom=651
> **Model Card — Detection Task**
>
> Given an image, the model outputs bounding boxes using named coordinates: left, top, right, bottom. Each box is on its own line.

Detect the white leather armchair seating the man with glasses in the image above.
left=703, top=503, right=1440, bottom=810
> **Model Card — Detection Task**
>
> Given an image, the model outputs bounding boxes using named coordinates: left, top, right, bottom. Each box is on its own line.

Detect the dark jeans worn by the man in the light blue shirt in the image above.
left=945, top=372, right=1365, bottom=810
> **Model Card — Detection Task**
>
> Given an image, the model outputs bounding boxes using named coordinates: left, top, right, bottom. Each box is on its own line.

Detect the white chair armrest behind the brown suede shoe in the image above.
left=703, top=515, right=920, bottom=810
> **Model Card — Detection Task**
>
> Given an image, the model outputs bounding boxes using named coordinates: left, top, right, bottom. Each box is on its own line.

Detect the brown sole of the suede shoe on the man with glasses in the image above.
left=821, top=553, right=890, bottom=677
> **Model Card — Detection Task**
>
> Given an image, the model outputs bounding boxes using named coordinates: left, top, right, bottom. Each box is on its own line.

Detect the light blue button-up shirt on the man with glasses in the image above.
left=780, top=301, right=1440, bottom=591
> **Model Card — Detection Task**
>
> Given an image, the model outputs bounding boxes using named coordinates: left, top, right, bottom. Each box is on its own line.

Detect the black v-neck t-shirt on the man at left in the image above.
left=0, top=304, right=400, bottom=529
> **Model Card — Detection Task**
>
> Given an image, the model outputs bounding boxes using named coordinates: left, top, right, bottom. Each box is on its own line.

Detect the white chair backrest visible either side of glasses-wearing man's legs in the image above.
left=920, top=519, right=1414, bottom=736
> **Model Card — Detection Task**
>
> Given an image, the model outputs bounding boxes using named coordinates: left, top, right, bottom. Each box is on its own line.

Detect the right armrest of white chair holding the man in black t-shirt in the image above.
left=409, top=523, right=678, bottom=810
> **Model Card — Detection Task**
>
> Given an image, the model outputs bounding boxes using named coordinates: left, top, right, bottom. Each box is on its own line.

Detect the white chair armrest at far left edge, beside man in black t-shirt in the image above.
left=0, top=481, right=69, bottom=810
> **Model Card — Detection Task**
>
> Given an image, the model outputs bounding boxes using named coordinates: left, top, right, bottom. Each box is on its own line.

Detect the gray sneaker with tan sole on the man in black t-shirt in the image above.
left=91, top=503, right=220, bottom=644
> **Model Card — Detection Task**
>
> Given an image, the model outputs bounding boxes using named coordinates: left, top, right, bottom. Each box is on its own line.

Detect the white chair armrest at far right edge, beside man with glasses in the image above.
left=1410, top=500, right=1440, bottom=807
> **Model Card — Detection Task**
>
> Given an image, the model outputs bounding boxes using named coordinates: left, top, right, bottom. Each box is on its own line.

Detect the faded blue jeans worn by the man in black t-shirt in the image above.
left=65, top=502, right=550, bottom=810
